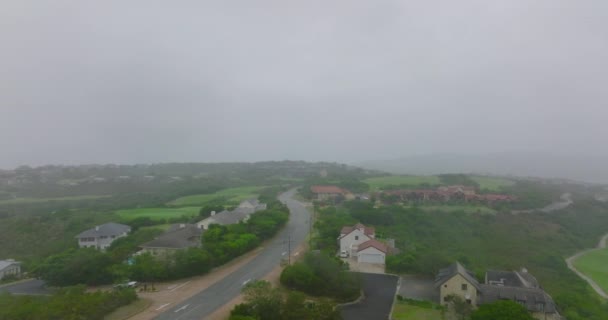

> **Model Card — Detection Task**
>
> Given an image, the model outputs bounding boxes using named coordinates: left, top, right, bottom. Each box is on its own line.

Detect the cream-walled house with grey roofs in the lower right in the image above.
left=435, top=262, right=561, bottom=320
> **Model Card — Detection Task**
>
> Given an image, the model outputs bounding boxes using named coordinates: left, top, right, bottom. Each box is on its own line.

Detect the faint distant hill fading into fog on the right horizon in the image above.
left=354, top=153, right=608, bottom=184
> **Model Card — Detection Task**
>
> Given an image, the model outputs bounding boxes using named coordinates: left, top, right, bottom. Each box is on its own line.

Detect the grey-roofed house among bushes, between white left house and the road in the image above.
left=140, top=223, right=203, bottom=256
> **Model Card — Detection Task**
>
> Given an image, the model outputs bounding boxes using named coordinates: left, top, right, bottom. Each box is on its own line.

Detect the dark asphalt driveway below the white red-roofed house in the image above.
left=341, top=273, right=399, bottom=320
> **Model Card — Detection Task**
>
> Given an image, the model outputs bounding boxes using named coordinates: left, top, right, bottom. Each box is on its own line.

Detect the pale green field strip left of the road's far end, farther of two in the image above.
left=167, top=186, right=263, bottom=207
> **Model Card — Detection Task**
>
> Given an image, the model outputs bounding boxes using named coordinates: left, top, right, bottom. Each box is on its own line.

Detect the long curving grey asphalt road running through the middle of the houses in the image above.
left=155, top=190, right=310, bottom=320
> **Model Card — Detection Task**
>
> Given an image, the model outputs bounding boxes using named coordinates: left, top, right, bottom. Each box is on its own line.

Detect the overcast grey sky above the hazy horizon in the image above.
left=0, top=0, right=608, bottom=167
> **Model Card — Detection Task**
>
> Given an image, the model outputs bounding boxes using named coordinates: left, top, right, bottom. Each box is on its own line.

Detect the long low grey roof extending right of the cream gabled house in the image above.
left=478, top=284, right=556, bottom=313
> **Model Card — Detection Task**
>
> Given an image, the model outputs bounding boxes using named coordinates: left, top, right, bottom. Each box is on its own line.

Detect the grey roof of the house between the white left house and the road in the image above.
left=141, top=224, right=203, bottom=249
